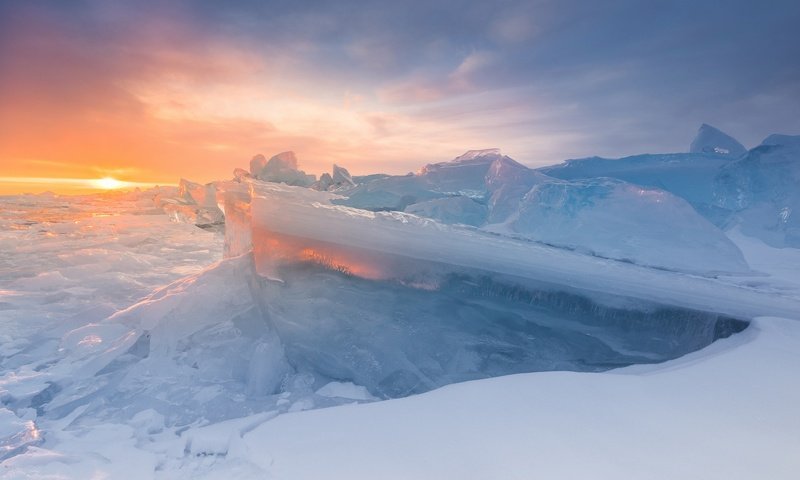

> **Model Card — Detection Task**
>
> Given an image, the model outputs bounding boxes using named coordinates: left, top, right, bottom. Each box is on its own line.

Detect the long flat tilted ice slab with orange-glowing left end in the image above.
left=251, top=184, right=798, bottom=316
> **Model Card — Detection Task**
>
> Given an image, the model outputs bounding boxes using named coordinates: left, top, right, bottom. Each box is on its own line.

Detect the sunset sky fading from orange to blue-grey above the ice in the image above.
left=0, top=0, right=800, bottom=193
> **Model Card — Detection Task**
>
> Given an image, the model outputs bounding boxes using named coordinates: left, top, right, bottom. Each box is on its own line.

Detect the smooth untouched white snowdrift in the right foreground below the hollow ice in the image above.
left=239, top=318, right=800, bottom=479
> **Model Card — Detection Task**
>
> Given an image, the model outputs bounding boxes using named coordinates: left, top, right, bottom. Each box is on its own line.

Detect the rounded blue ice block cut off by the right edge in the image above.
left=714, top=135, right=800, bottom=248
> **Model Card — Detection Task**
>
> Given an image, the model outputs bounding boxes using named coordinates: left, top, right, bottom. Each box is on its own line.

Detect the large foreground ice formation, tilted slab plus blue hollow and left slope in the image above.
left=7, top=180, right=768, bottom=426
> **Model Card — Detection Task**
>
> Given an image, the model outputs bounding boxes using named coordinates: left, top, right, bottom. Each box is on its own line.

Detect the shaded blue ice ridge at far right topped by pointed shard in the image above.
left=539, top=125, right=800, bottom=247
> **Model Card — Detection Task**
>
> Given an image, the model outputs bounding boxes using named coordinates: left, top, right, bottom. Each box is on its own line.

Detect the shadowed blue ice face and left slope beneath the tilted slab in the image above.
left=44, top=244, right=745, bottom=412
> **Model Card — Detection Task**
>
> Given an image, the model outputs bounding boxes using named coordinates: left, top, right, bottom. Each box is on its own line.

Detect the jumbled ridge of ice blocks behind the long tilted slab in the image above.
left=155, top=124, right=797, bottom=262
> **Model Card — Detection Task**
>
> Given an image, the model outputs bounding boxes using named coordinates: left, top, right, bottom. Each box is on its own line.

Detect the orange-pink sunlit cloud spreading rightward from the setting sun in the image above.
left=0, top=6, right=524, bottom=193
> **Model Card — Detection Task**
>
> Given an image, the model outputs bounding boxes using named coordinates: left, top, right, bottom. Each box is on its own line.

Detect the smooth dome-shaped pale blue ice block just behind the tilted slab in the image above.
left=502, top=178, right=749, bottom=273
